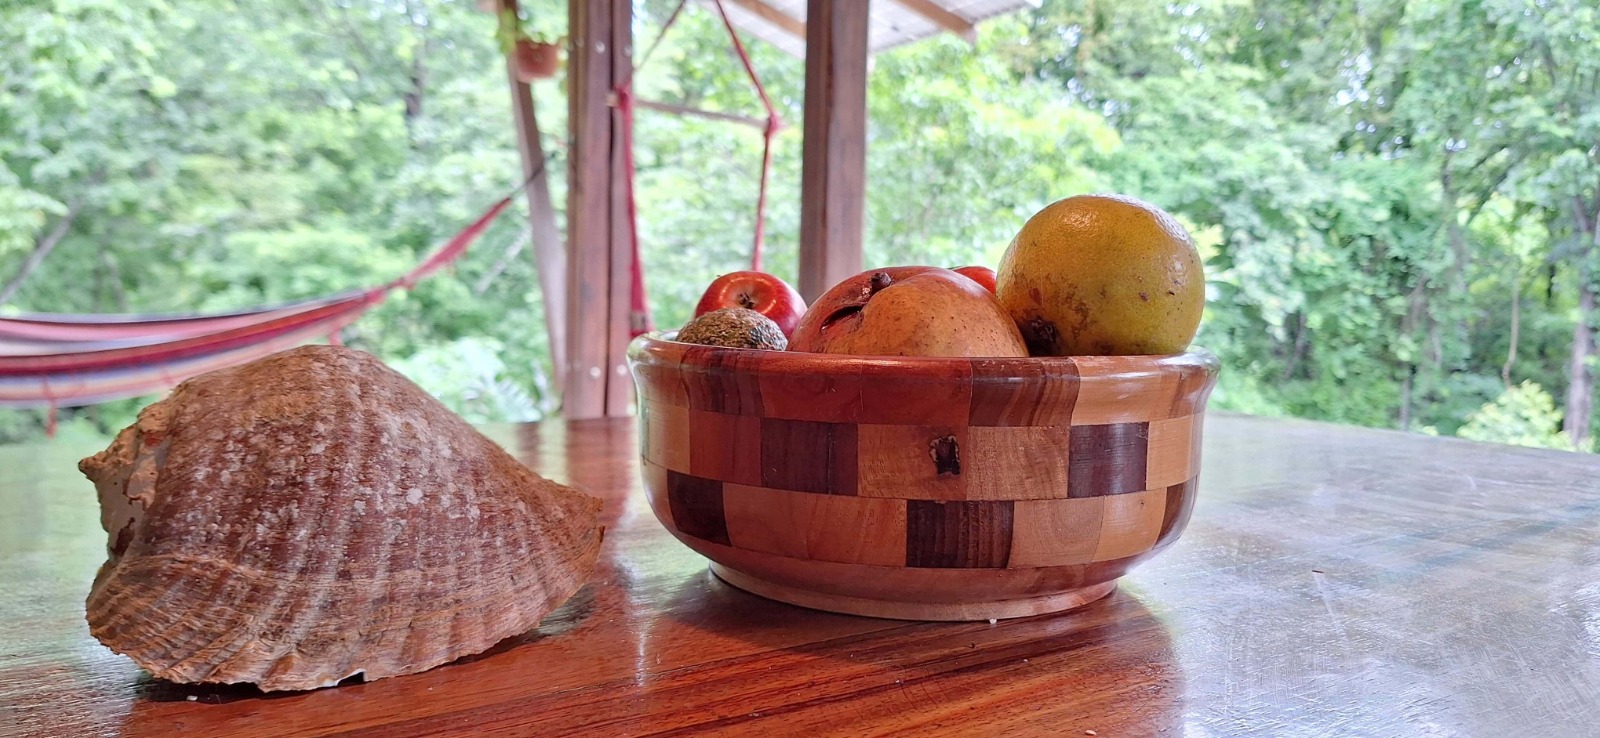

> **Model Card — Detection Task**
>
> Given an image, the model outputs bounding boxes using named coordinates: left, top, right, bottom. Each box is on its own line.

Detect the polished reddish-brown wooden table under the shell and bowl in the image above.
left=0, top=415, right=1600, bottom=738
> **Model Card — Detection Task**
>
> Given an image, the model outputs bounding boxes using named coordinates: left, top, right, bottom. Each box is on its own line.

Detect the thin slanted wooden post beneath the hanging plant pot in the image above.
left=501, top=0, right=566, bottom=392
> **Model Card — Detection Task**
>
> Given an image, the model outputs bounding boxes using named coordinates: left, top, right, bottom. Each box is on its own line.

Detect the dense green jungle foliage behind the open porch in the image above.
left=0, top=0, right=1600, bottom=450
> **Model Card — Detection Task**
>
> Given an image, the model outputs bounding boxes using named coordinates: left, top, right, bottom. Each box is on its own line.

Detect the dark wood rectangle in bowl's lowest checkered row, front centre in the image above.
left=906, top=499, right=1011, bottom=568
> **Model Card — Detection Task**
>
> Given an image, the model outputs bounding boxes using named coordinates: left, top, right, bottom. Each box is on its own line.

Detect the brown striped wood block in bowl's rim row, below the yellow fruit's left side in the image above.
left=968, top=359, right=1078, bottom=426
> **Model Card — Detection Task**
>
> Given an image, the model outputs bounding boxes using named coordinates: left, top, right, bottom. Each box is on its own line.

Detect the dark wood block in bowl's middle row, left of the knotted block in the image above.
left=762, top=418, right=858, bottom=495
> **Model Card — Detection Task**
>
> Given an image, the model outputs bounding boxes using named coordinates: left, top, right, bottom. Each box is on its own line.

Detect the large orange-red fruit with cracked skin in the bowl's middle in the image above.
left=789, top=267, right=1027, bottom=357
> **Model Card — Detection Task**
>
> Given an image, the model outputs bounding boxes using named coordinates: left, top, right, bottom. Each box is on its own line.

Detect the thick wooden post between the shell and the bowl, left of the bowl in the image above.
left=562, top=0, right=632, bottom=418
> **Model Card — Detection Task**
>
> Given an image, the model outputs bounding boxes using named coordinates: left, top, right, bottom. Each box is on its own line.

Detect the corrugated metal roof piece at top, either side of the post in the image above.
left=701, top=0, right=1040, bottom=58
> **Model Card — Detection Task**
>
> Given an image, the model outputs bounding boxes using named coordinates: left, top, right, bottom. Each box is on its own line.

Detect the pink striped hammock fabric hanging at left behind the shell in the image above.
left=0, top=187, right=520, bottom=409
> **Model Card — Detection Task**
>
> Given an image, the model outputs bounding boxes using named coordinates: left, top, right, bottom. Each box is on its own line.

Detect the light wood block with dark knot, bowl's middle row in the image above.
left=856, top=424, right=974, bottom=499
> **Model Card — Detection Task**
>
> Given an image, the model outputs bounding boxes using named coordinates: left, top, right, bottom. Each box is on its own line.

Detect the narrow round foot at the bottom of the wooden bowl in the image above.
left=710, top=562, right=1117, bottom=621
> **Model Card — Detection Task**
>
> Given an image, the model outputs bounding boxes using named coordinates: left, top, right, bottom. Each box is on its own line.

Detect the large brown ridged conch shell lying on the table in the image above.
left=78, top=346, right=602, bottom=690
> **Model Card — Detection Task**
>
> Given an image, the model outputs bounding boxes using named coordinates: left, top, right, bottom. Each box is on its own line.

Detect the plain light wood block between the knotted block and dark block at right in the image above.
left=963, top=426, right=1072, bottom=499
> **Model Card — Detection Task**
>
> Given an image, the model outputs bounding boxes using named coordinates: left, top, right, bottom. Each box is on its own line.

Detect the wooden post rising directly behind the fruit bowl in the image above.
left=800, top=0, right=869, bottom=301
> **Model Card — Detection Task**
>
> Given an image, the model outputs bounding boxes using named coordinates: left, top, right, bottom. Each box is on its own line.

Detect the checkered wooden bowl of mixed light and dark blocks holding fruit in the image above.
left=629, top=333, right=1218, bottom=620
